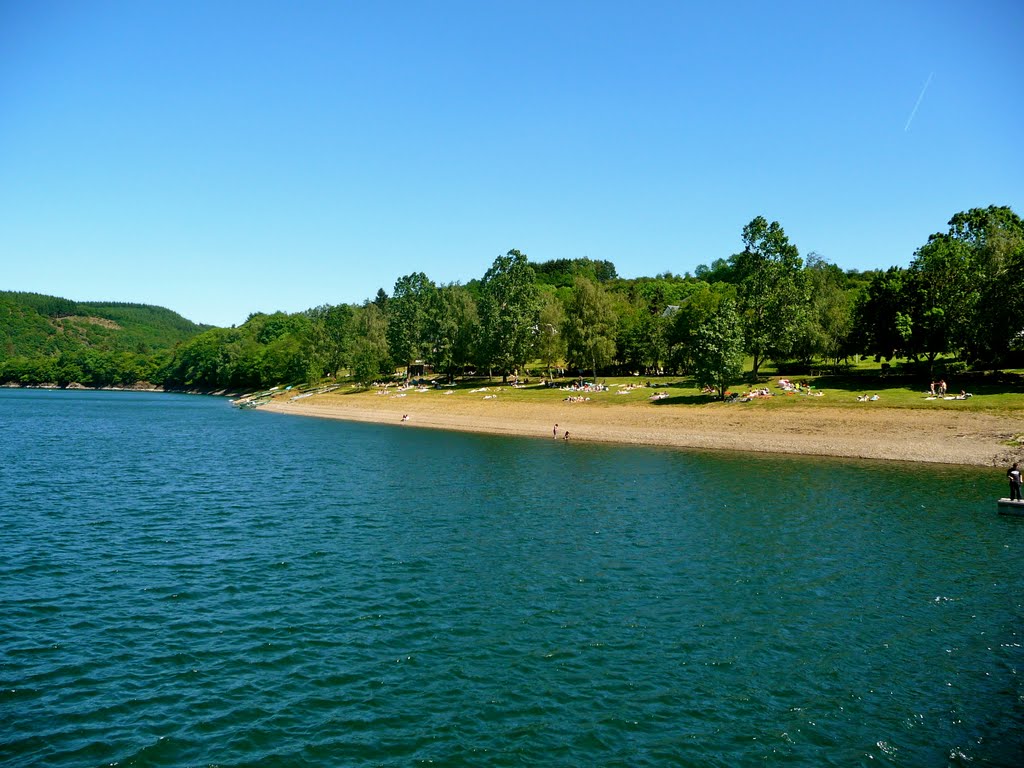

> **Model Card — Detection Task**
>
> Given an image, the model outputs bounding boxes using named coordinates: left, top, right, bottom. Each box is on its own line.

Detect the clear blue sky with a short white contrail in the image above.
left=0, top=0, right=1024, bottom=326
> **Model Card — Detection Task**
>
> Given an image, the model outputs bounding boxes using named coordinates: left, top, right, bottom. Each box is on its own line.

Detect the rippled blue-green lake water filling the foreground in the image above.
left=0, top=390, right=1024, bottom=766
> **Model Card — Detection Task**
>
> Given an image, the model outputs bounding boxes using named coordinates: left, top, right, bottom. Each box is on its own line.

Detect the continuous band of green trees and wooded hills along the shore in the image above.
left=0, top=206, right=1024, bottom=391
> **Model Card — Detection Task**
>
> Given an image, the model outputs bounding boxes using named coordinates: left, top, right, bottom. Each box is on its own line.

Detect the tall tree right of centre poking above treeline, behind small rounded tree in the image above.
left=733, top=216, right=807, bottom=378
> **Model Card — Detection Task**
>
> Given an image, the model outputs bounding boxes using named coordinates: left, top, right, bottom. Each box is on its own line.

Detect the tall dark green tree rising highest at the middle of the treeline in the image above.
left=479, top=249, right=540, bottom=381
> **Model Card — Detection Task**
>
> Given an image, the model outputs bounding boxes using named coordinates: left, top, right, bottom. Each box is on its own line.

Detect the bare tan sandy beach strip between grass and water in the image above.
left=261, top=391, right=1024, bottom=467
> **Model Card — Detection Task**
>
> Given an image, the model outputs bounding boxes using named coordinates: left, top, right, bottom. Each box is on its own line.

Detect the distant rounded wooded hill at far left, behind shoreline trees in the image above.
left=0, top=291, right=210, bottom=360
